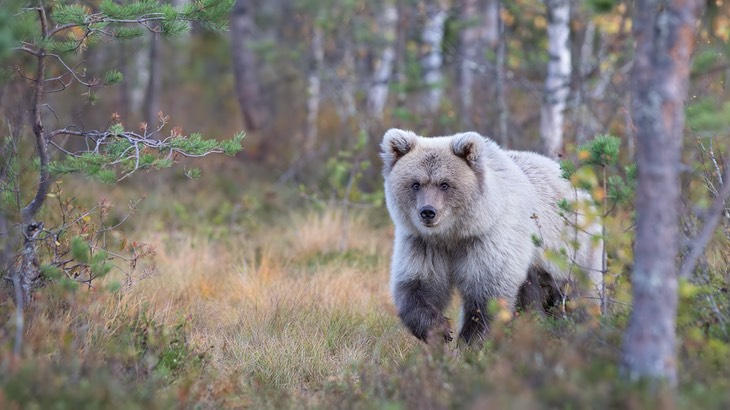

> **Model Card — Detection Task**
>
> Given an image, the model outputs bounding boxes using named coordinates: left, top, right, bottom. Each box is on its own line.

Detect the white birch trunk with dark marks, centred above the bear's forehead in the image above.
left=421, top=0, right=447, bottom=113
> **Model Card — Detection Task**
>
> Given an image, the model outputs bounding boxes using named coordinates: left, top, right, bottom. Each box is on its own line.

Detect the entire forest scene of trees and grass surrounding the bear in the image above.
left=0, top=0, right=730, bottom=409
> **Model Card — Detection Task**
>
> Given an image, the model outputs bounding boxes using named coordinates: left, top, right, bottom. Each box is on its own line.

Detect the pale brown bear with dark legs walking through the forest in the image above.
left=381, top=128, right=603, bottom=345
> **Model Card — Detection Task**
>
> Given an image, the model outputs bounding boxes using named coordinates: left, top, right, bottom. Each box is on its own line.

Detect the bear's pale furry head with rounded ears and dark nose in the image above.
left=381, top=129, right=487, bottom=236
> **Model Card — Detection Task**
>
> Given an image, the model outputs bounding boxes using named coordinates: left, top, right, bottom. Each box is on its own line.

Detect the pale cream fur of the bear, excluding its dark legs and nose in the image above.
left=382, top=129, right=602, bottom=340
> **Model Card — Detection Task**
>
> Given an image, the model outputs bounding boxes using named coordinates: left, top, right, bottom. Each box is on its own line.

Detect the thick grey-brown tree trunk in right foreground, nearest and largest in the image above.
left=623, top=0, right=702, bottom=385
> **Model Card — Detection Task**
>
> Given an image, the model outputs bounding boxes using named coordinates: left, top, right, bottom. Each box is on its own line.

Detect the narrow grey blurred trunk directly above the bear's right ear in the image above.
left=459, top=0, right=479, bottom=128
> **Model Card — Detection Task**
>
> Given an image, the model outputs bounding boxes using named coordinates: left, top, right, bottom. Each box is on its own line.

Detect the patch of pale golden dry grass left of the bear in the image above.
left=114, top=210, right=417, bottom=404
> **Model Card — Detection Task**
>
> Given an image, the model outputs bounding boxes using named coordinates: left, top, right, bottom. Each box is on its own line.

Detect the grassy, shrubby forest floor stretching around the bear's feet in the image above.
left=0, top=166, right=730, bottom=409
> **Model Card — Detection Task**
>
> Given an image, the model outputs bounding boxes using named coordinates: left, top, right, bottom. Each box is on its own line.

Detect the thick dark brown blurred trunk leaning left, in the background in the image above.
left=231, top=0, right=269, bottom=132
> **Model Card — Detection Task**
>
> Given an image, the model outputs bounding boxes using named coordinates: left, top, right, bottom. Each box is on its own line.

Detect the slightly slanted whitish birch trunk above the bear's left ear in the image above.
left=368, top=0, right=398, bottom=120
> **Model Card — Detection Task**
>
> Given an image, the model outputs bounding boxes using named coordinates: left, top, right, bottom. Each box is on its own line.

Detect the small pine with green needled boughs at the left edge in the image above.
left=0, top=0, right=244, bottom=302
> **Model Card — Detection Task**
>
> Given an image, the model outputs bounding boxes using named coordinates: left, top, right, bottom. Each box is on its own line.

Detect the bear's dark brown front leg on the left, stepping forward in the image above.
left=394, top=279, right=452, bottom=343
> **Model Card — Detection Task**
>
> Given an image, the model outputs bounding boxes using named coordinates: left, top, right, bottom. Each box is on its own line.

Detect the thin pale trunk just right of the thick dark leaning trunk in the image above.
left=304, top=22, right=324, bottom=152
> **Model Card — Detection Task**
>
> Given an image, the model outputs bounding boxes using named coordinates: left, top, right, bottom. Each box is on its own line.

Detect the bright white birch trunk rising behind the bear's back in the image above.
left=540, top=0, right=571, bottom=159
